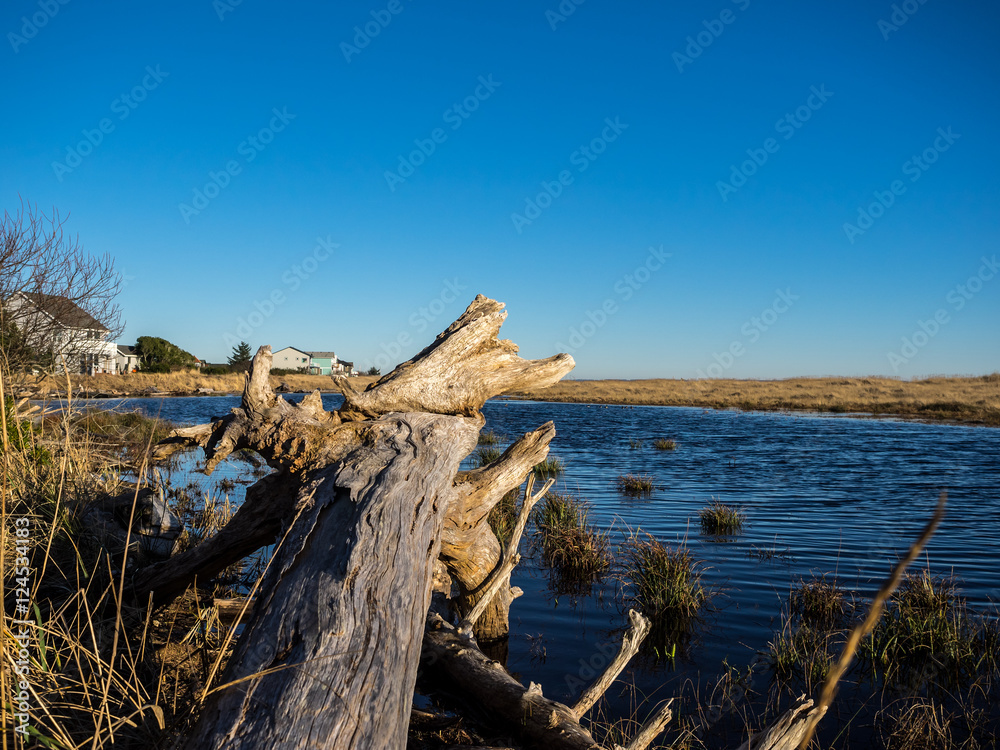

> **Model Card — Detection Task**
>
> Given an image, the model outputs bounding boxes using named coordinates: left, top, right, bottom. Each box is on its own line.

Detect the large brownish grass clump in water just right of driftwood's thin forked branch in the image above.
left=532, top=493, right=611, bottom=580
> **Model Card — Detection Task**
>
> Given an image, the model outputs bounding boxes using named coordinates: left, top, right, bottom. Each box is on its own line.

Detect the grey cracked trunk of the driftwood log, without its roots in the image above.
left=187, top=414, right=479, bottom=750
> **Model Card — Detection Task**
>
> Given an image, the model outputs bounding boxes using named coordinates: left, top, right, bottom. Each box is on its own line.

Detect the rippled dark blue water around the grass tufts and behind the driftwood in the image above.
left=80, top=395, right=1000, bottom=748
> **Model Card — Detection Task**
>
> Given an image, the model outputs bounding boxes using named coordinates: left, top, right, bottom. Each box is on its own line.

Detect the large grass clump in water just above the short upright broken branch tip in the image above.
left=623, top=533, right=709, bottom=629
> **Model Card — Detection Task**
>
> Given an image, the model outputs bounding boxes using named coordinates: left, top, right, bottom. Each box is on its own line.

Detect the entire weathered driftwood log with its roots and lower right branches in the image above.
left=132, top=295, right=844, bottom=750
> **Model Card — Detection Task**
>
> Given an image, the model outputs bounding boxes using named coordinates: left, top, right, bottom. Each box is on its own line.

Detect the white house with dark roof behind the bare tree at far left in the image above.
left=8, top=292, right=118, bottom=375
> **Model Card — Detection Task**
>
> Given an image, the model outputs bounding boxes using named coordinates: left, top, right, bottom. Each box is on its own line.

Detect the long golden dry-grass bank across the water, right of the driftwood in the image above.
left=513, top=373, right=1000, bottom=426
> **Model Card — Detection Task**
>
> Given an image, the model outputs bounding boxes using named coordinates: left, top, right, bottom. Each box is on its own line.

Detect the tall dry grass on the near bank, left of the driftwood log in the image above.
left=0, top=378, right=262, bottom=748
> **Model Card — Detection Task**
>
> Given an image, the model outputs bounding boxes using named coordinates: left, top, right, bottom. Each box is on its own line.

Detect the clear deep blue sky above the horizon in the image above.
left=0, top=0, right=1000, bottom=378
